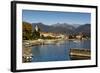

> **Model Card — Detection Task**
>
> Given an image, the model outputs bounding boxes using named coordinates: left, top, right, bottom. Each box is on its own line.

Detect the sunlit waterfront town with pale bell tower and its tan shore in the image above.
left=23, top=25, right=88, bottom=46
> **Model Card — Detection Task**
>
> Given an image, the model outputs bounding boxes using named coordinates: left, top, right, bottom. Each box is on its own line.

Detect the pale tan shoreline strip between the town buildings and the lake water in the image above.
left=22, top=39, right=90, bottom=47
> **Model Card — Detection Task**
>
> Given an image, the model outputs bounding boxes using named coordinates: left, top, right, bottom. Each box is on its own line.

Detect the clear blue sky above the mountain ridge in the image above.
left=22, top=10, right=91, bottom=25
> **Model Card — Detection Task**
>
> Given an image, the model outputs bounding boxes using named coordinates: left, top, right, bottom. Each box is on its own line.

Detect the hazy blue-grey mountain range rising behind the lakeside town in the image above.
left=22, top=23, right=91, bottom=36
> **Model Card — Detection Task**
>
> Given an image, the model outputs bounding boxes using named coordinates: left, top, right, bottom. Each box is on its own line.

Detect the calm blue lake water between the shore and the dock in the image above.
left=32, top=40, right=90, bottom=62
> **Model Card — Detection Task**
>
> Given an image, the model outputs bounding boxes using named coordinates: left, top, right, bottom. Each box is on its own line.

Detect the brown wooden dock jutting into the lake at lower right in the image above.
left=70, top=48, right=91, bottom=60
